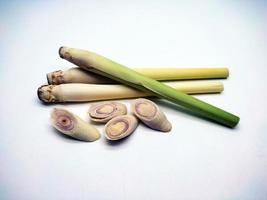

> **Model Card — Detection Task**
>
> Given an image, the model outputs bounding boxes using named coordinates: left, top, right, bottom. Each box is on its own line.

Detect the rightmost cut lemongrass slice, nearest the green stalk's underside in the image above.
left=132, top=98, right=172, bottom=132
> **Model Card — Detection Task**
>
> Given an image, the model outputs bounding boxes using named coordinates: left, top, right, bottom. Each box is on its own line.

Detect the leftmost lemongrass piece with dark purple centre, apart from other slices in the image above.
left=51, top=108, right=100, bottom=142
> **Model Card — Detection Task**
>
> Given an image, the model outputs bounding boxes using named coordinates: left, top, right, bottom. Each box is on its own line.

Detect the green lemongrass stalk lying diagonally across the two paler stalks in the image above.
left=59, top=47, right=239, bottom=127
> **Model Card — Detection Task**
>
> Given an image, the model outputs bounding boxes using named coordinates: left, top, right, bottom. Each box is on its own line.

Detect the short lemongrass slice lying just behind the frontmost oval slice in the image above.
left=89, top=102, right=127, bottom=123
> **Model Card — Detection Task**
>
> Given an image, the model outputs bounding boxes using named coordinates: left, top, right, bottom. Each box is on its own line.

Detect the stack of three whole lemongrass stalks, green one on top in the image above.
left=38, top=47, right=239, bottom=128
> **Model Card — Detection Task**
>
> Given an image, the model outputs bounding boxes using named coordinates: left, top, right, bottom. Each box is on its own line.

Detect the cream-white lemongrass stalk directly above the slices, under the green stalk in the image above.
left=38, top=81, right=223, bottom=103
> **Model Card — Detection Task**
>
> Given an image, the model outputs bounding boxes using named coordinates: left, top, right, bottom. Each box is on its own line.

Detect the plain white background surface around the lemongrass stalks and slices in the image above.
left=0, top=0, right=267, bottom=200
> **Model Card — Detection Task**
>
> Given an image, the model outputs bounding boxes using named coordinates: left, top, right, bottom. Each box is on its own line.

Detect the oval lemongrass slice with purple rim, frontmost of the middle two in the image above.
left=105, top=115, right=138, bottom=140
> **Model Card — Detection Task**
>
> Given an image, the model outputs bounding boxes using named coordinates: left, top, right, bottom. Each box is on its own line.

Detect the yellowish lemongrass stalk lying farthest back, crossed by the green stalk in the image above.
left=47, top=67, right=229, bottom=85
